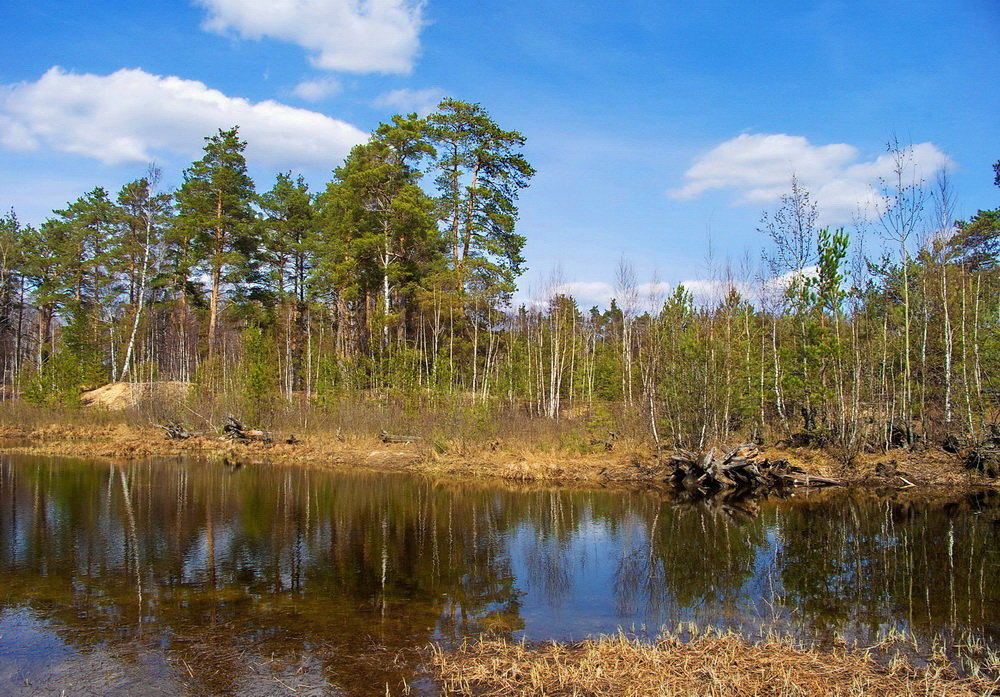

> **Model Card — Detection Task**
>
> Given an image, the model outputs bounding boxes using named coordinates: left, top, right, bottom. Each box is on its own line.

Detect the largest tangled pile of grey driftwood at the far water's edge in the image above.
left=670, top=443, right=841, bottom=492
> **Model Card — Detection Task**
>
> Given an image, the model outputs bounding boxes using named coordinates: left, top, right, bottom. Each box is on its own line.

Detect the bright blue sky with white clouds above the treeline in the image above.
left=0, top=0, right=1000, bottom=303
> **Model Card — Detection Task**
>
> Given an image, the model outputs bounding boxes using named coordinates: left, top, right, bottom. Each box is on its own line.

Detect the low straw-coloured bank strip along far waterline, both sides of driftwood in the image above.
left=0, top=424, right=1000, bottom=488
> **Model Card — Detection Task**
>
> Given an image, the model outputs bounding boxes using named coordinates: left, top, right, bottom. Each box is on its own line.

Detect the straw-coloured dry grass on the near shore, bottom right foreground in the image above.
left=431, top=632, right=1000, bottom=697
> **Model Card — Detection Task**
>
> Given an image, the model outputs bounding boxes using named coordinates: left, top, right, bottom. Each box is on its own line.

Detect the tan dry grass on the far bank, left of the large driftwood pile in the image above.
left=0, top=394, right=662, bottom=481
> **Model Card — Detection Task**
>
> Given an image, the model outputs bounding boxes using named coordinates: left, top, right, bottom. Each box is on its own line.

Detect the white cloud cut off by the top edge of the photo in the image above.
left=196, top=0, right=424, bottom=73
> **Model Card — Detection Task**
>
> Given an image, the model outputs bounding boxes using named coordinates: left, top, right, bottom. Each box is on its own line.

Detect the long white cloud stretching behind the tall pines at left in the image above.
left=0, top=67, right=366, bottom=169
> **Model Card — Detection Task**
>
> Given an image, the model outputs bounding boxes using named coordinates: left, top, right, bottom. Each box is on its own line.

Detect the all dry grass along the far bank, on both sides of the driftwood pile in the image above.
left=0, top=394, right=1000, bottom=488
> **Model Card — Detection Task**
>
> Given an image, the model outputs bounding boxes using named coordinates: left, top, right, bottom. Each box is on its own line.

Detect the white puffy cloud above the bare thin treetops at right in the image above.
left=669, top=133, right=951, bottom=224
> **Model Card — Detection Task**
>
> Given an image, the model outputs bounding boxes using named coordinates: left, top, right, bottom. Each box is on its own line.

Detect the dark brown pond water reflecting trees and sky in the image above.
left=0, top=455, right=1000, bottom=695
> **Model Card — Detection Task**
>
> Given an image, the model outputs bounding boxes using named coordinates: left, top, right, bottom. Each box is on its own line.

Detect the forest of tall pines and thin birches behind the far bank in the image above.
left=0, top=99, right=1000, bottom=462
